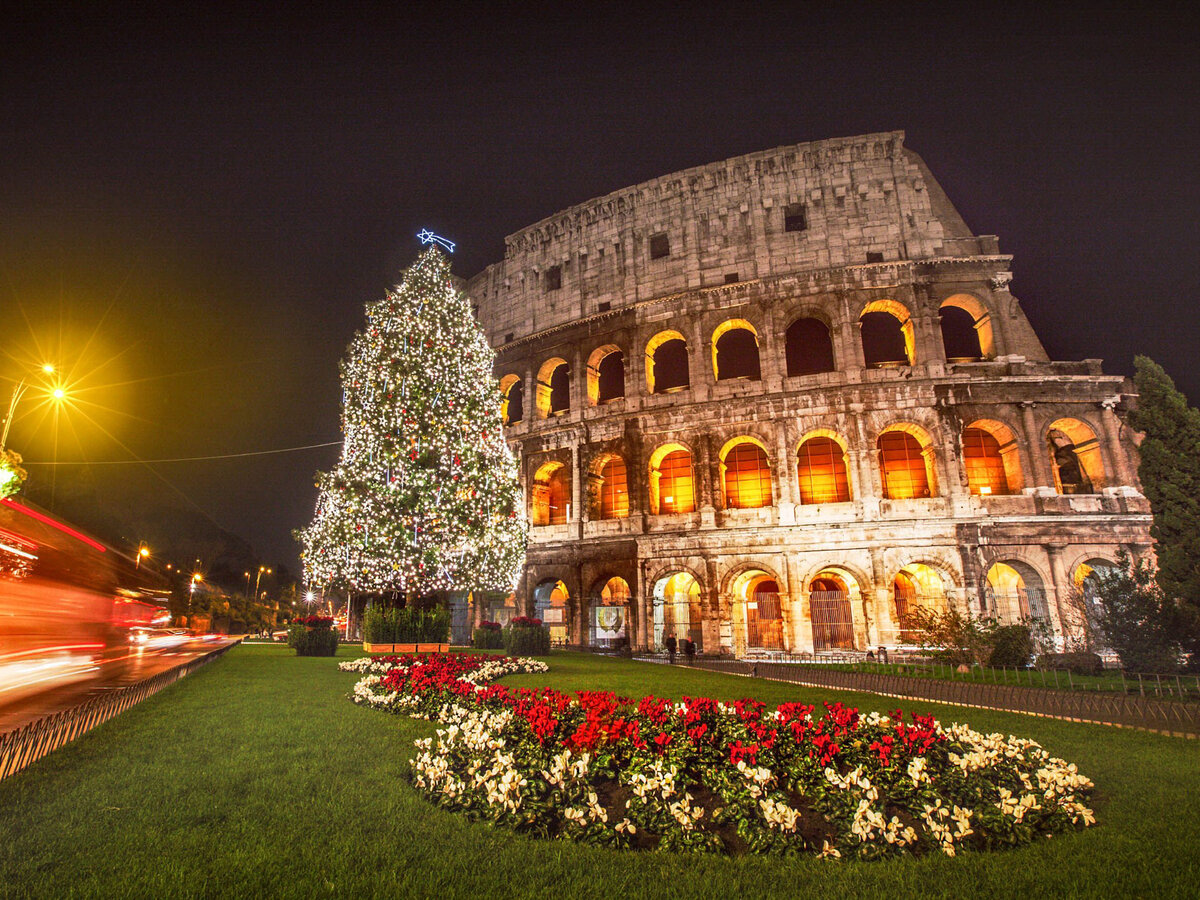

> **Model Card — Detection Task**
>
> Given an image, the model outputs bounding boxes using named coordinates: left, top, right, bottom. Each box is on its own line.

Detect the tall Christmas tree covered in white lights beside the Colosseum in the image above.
left=298, top=246, right=527, bottom=595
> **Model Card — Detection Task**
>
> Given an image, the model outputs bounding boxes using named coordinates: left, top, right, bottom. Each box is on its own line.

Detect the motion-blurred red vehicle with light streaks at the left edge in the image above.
left=0, top=497, right=170, bottom=703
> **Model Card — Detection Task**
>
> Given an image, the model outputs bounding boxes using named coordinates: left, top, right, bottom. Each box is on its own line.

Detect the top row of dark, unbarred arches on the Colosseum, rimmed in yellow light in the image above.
left=500, top=294, right=995, bottom=425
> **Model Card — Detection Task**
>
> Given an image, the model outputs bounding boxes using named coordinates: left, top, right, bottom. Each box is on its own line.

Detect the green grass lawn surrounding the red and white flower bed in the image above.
left=0, top=646, right=1200, bottom=898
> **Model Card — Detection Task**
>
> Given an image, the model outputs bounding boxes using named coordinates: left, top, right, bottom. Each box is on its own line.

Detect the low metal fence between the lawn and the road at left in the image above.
left=0, top=642, right=236, bottom=780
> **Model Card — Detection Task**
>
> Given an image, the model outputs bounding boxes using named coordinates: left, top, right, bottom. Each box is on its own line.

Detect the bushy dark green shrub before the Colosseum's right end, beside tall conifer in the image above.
left=1093, top=551, right=1184, bottom=672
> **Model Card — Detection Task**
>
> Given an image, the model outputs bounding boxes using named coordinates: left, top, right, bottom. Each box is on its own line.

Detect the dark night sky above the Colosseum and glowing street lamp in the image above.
left=0, top=2, right=1200, bottom=571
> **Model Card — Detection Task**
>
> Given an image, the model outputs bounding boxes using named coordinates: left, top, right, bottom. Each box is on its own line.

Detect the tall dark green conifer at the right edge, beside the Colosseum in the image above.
left=1129, top=356, right=1200, bottom=665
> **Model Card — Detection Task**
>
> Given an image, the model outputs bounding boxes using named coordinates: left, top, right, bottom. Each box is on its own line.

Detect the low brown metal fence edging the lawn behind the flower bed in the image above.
left=676, top=659, right=1200, bottom=738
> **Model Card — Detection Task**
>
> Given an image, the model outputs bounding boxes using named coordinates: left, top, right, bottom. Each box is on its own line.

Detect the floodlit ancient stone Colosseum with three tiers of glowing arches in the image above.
left=467, top=132, right=1151, bottom=656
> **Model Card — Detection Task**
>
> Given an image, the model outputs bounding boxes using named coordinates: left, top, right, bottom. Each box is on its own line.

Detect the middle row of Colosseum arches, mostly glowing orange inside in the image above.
left=530, top=419, right=1104, bottom=526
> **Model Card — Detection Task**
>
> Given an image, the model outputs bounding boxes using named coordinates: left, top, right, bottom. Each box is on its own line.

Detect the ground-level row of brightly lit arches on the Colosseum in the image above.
left=518, top=558, right=1115, bottom=653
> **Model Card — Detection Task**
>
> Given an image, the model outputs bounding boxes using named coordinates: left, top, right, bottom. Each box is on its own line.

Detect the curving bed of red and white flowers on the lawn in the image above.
left=341, top=655, right=1096, bottom=858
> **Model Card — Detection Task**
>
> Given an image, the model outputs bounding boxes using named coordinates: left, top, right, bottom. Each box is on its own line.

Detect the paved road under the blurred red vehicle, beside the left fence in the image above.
left=0, top=640, right=232, bottom=734
